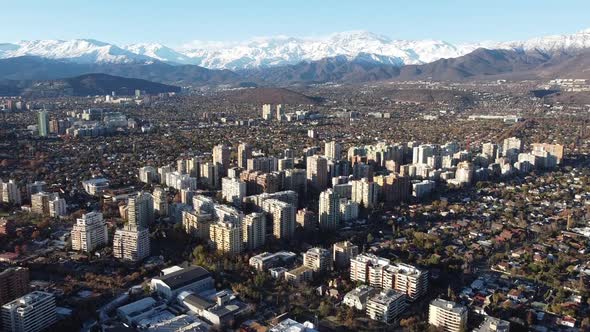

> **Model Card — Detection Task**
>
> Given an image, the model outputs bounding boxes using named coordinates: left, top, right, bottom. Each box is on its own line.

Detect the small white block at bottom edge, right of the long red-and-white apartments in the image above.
left=428, top=299, right=467, bottom=332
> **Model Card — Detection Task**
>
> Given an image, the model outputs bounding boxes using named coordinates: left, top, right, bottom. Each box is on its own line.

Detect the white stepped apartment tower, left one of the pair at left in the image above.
left=71, top=212, right=108, bottom=252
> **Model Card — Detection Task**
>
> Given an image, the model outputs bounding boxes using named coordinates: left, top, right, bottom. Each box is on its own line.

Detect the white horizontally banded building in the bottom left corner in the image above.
left=2, top=291, right=57, bottom=332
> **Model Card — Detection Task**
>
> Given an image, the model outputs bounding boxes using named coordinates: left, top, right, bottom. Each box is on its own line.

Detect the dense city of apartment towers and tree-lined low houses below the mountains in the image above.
left=0, top=76, right=590, bottom=331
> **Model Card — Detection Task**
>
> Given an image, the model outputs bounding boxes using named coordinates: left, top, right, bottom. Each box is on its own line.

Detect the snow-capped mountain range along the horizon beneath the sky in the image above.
left=0, top=29, right=590, bottom=70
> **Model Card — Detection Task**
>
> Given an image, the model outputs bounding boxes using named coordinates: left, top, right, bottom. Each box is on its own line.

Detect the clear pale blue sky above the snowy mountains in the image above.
left=0, top=0, right=590, bottom=46
